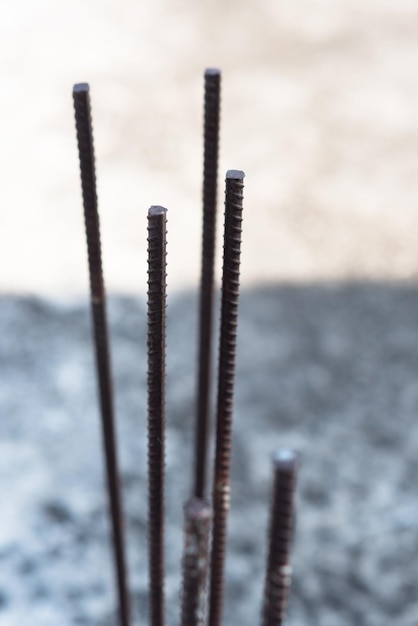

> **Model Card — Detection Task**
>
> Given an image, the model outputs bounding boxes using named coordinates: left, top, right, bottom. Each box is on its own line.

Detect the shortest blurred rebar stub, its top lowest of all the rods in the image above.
left=180, top=498, right=212, bottom=626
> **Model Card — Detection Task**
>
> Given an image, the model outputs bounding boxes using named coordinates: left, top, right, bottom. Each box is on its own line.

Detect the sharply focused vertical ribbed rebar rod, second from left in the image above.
left=147, top=206, right=167, bottom=626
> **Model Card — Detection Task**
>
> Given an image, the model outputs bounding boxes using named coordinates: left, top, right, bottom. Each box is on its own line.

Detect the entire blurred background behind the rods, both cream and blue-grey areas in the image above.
left=0, top=0, right=418, bottom=626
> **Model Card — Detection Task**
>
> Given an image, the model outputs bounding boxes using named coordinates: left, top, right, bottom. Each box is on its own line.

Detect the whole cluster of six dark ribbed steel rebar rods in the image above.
left=73, top=69, right=298, bottom=626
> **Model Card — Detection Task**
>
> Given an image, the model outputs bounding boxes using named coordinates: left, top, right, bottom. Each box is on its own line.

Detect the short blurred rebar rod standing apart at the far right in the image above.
left=262, top=448, right=298, bottom=626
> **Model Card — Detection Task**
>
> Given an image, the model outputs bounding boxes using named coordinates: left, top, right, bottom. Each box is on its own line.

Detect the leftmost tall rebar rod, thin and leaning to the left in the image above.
left=73, top=83, right=130, bottom=626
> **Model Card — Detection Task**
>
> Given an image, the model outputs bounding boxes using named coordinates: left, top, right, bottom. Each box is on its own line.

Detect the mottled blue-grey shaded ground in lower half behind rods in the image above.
left=0, top=282, right=418, bottom=626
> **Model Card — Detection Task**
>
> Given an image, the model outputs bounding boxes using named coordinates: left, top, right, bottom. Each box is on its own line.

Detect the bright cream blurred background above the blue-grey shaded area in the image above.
left=0, top=0, right=418, bottom=295
